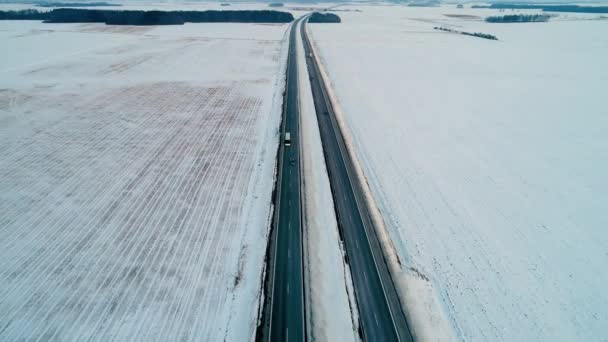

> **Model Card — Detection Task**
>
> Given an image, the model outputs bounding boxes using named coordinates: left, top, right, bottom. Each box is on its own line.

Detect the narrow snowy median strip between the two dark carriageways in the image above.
left=296, top=20, right=358, bottom=341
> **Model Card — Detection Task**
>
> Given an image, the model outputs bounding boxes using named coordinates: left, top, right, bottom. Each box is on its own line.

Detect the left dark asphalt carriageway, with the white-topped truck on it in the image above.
left=261, top=14, right=306, bottom=341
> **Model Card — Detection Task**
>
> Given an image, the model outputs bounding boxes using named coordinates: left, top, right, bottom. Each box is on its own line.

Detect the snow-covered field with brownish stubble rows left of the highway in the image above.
left=0, top=21, right=287, bottom=341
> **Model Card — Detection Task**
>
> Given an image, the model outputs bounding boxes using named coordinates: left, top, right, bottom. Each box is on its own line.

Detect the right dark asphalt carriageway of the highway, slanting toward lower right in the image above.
left=301, top=18, right=412, bottom=341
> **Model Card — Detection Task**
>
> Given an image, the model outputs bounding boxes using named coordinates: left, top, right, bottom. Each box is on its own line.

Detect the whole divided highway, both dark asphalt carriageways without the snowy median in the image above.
left=258, top=17, right=413, bottom=342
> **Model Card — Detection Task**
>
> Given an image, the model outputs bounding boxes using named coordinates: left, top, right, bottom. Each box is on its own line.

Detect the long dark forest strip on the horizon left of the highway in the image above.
left=0, top=8, right=293, bottom=25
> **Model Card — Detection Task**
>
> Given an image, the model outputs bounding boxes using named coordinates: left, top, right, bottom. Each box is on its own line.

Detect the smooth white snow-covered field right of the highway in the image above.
left=309, top=5, right=608, bottom=341
